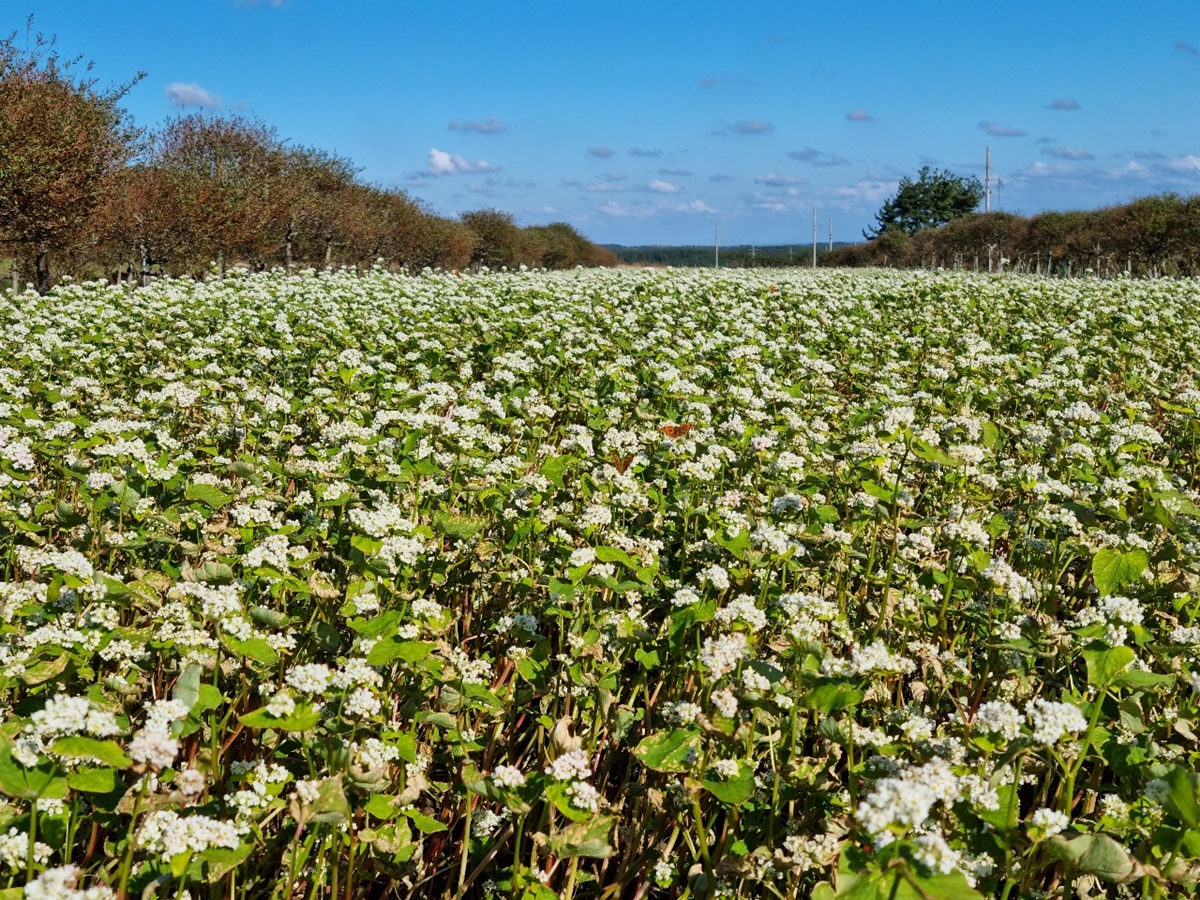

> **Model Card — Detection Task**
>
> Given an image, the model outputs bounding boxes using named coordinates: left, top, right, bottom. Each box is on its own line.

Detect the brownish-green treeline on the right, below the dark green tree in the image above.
left=821, top=193, right=1200, bottom=277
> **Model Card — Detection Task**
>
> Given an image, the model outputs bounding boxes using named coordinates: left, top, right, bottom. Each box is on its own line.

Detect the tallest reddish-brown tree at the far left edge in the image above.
left=0, top=23, right=143, bottom=293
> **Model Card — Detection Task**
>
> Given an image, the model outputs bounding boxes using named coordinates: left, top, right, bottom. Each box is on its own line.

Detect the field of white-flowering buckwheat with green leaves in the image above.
left=0, top=270, right=1200, bottom=900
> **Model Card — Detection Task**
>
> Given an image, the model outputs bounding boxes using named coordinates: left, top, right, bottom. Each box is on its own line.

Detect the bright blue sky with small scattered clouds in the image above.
left=16, top=0, right=1200, bottom=245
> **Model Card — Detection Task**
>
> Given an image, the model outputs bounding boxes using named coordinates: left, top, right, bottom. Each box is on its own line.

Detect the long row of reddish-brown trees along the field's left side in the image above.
left=0, top=27, right=617, bottom=292
